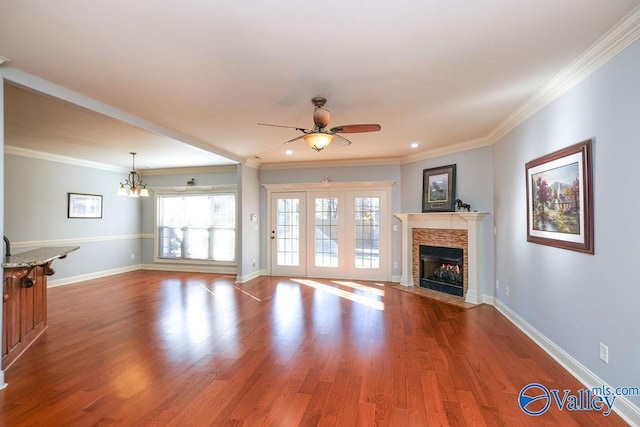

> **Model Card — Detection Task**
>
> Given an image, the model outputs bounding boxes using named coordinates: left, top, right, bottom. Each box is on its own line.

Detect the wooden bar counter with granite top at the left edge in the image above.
left=2, top=246, right=79, bottom=370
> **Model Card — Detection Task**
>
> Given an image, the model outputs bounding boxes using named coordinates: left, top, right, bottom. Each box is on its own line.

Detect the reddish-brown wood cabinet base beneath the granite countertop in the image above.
left=2, top=264, right=53, bottom=369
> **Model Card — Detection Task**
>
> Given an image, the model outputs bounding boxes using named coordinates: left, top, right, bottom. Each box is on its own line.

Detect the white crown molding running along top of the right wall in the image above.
left=486, top=6, right=640, bottom=144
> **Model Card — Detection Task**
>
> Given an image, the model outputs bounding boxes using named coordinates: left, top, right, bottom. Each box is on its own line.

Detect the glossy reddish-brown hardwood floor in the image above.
left=0, top=271, right=624, bottom=426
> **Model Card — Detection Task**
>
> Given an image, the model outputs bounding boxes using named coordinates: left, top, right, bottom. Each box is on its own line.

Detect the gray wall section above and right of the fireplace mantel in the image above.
left=402, top=147, right=494, bottom=297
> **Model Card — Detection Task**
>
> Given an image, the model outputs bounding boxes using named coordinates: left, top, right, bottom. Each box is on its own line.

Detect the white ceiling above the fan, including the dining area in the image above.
left=0, top=0, right=640, bottom=168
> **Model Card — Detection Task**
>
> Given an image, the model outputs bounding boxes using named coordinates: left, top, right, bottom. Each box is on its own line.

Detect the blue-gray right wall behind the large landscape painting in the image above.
left=493, top=43, right=640, bottom=405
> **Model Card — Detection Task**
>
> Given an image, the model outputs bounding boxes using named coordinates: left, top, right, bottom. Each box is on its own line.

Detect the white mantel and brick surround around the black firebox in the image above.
left=395, top=212, right=488, bottom=304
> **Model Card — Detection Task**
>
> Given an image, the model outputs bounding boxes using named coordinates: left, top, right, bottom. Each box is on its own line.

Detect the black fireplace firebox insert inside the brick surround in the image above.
left=419, top=245, right=464, bottom=297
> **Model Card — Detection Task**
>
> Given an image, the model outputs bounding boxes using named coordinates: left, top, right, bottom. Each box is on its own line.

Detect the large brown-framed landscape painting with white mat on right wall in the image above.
left=525, top=140, right=593, bottom=254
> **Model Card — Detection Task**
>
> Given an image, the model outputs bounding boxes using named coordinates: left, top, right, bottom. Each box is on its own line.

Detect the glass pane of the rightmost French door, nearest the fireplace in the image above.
left=354, top=197, right=380, bottom=269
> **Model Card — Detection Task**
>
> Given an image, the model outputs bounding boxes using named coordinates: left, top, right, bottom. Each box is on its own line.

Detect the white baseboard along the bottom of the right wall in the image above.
left=492, top=295, right=640, bottom=426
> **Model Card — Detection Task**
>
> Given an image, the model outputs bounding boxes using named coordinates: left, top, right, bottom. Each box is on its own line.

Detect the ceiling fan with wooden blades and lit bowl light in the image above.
left=258, top=96, right=381, bottom=151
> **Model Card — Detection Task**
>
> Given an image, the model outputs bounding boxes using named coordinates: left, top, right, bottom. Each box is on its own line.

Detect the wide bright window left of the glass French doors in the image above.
left=157, top=193, right=236, bottom=261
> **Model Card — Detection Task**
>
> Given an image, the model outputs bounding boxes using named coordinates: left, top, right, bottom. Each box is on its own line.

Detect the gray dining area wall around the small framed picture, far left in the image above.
left=4, top=154, right=140, bottom=284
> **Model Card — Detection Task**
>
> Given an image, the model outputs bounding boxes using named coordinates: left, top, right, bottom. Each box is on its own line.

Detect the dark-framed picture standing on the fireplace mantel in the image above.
left=422, top=165, right=456, bottom=212
